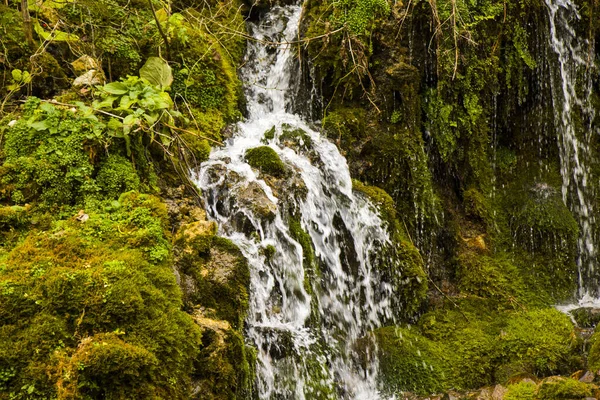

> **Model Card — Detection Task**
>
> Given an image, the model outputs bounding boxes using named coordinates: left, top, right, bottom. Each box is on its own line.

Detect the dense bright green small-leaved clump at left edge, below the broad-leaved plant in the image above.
left=1, top=98, right=109, bottom=206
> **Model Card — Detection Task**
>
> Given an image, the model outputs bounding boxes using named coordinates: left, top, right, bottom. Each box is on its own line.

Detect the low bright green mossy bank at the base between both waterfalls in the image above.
left=376, top=308, right=582, bottom=398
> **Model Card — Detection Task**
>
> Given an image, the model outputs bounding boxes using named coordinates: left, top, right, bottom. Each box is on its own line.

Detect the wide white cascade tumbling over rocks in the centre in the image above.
left=197, top=6, right=393, bottom=399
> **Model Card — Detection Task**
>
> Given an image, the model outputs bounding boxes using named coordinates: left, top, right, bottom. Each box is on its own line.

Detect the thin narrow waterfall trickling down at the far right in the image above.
left=545, top=0, right=600, bottom=301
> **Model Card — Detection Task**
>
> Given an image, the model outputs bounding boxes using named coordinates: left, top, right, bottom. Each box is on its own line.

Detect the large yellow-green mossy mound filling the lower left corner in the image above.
left=0, top=193, right=201, bottom=398
